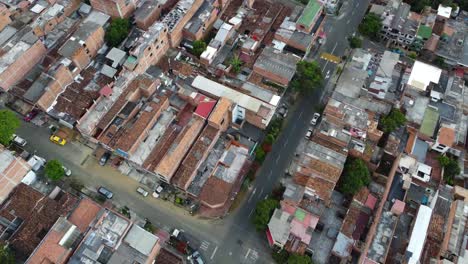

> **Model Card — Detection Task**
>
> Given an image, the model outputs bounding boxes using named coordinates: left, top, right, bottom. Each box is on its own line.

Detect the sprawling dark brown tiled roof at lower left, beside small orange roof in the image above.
left=0, top=183, right=78, bottom=257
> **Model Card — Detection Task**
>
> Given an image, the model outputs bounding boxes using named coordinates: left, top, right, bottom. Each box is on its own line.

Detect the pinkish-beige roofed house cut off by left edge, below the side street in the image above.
left=0, top=145, right=35, bottom=204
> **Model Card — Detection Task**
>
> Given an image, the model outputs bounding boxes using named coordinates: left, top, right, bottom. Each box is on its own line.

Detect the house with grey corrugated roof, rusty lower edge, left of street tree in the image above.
left=253, top=47, right=300, bottom=86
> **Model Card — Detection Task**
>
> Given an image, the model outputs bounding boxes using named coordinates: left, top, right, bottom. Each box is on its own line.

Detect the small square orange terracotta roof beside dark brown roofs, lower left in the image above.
left=68, top=198, right=102, bottom=233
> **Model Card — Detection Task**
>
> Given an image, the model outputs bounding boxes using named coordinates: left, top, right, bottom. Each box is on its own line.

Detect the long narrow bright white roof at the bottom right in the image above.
left=406, top=205, right=432, bottom=264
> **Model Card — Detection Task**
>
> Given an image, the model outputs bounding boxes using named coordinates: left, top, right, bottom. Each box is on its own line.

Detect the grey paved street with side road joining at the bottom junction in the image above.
left=11, top=0, right=369, bottom=264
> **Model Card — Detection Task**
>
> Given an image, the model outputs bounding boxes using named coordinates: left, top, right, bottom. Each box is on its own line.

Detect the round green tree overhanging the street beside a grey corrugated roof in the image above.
left=290, top=61, right=323, bottom=94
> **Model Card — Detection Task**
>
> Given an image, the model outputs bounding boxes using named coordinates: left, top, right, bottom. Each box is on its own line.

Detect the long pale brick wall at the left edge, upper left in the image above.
left=0, top=41, right=47, bottom=91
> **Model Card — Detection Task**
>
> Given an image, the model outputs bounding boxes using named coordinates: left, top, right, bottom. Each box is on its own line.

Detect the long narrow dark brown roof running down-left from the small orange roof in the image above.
left=172, top=125, right=219, bottom=190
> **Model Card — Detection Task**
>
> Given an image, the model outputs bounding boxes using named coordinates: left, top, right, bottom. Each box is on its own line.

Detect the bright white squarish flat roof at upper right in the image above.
left=408, top=61, right=442, bottom=91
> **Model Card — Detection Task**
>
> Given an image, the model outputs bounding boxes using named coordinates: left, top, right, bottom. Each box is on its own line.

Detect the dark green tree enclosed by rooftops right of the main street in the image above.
left=340, top=159, right=370, bottom=195
